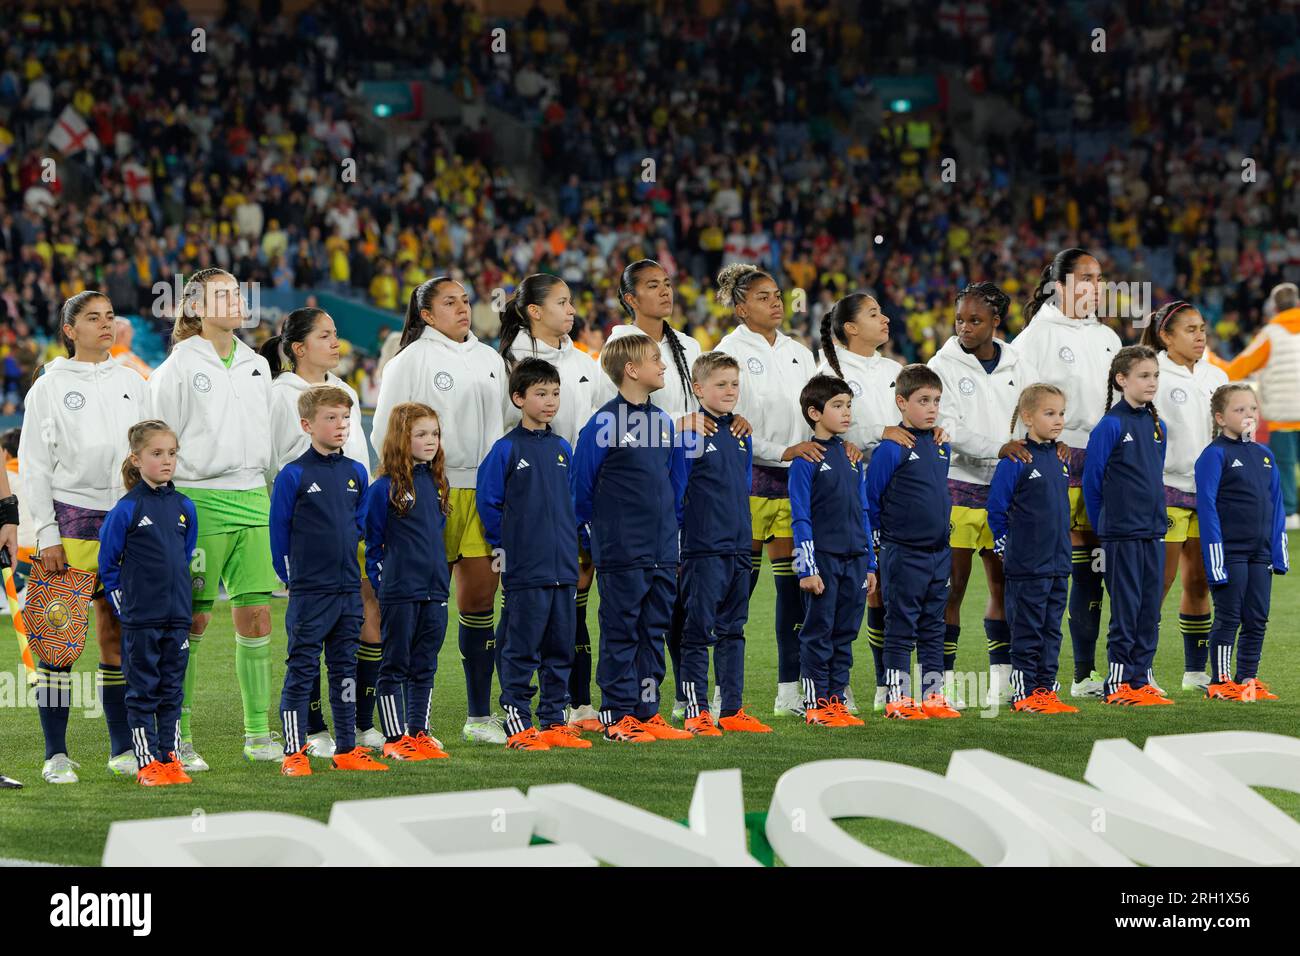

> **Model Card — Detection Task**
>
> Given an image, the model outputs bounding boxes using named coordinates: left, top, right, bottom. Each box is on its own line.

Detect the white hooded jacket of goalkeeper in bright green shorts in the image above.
left=150, top=336, right=270, bottom=492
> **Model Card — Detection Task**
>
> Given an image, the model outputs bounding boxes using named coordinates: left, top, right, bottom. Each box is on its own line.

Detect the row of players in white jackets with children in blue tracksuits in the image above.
left=20, top=250, right=1287, bottom=784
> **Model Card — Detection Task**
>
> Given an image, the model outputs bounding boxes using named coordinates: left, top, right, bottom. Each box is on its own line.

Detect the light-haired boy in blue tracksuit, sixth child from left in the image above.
left=677, top=351, right=772, bottom=736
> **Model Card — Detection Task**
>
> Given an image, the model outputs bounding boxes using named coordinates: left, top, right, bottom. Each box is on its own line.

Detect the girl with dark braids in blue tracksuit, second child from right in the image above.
left=1083, top=345, right=1174, bottom=706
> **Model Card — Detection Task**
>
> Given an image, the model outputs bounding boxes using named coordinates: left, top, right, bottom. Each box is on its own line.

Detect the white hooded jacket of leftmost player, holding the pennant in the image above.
left=18, top=359, right=152, bottom=549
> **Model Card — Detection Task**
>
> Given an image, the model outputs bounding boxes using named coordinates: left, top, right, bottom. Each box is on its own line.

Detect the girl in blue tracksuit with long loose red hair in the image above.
left=365, top=402, right=451, bottom=760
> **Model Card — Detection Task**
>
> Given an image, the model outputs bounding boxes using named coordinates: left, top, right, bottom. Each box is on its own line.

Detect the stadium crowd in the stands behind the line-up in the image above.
left=0, top=0, right=1300, bottom=411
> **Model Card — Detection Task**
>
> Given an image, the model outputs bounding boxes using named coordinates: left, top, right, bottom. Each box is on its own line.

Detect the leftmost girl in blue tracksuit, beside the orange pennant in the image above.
left=99, top=420, right=199, bottom=787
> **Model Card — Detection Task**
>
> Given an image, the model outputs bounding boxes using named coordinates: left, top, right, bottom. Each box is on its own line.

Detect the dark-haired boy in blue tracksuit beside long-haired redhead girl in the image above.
left=476, top=359, right=592, bottom=750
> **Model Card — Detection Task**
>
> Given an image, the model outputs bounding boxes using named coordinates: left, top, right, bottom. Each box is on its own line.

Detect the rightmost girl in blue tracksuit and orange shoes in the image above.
left=1195, top=384, right=1291, bottom=701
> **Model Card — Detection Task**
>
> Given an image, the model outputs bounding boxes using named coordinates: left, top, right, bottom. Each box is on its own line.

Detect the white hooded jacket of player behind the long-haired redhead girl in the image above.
left=371, top=325, right=510, bottom=488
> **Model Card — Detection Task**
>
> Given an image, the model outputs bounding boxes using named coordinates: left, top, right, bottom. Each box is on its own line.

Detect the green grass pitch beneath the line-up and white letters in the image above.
left=0, top=546, right=1300, bottom=865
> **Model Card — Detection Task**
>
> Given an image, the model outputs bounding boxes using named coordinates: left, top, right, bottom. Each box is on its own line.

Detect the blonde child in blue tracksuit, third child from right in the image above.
left=988, top=382, right=1079, bottom=714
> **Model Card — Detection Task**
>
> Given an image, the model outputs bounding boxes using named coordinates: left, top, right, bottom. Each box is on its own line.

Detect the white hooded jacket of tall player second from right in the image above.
left=1003, top=302, right=1122, bottom=449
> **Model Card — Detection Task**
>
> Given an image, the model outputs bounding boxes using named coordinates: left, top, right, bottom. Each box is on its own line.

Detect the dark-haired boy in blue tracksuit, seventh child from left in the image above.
left=789, top=375, right=876, bottom=727
